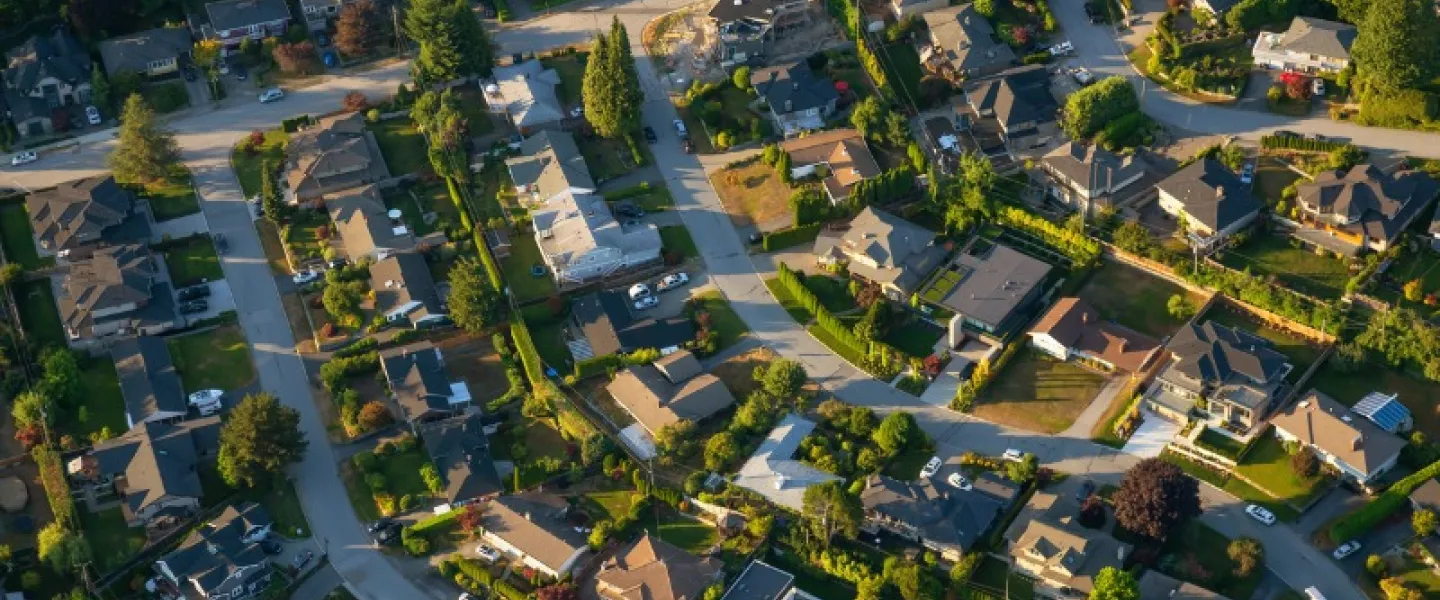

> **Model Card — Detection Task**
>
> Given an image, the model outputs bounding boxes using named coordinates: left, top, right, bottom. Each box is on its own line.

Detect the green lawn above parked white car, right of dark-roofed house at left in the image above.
left=170, top=325, right=255, bottom=393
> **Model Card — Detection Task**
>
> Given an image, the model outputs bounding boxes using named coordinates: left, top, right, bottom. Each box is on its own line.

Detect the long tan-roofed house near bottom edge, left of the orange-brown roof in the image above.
left=480, top=492, right=589, bottom=578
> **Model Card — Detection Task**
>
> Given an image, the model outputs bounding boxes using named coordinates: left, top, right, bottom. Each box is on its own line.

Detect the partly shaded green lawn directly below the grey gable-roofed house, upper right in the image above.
left=1220, top=233, right=1349, bottom=298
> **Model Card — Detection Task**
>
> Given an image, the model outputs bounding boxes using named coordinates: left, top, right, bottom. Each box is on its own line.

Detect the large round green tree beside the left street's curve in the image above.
left=219, top=391, right=310, bottom=488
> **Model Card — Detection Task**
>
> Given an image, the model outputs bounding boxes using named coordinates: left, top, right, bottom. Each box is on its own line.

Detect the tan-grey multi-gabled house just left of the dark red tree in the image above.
left=1009, top=518, right=1132, bottom=599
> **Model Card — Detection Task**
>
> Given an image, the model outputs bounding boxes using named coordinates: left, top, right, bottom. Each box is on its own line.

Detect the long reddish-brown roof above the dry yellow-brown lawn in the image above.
left=1030, top=296, right=1161, bottom=371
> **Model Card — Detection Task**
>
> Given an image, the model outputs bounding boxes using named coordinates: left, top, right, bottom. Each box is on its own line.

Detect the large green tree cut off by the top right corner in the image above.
left=1351, top=0, right=1440, bottom=92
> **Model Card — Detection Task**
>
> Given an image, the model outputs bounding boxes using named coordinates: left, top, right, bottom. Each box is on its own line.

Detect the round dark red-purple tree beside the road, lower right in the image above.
left=1112, top=459, right=1200, bottom=541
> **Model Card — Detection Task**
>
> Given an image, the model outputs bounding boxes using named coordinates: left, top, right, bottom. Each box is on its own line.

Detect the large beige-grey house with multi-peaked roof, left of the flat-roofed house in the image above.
left=814, top=206, right=946, bottom=302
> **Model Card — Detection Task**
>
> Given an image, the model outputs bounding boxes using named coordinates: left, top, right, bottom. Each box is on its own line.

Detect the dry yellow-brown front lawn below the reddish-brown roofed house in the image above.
left=975, top=351, right=1104, bottom=433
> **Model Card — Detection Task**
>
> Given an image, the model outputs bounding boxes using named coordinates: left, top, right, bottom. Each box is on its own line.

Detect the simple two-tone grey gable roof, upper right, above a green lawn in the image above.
left=1155, top=157, right=1260, bottom=232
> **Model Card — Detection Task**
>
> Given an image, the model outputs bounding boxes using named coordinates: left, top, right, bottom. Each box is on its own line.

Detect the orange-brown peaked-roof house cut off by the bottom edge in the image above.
left=595, top=531, right=724, bottom=600
